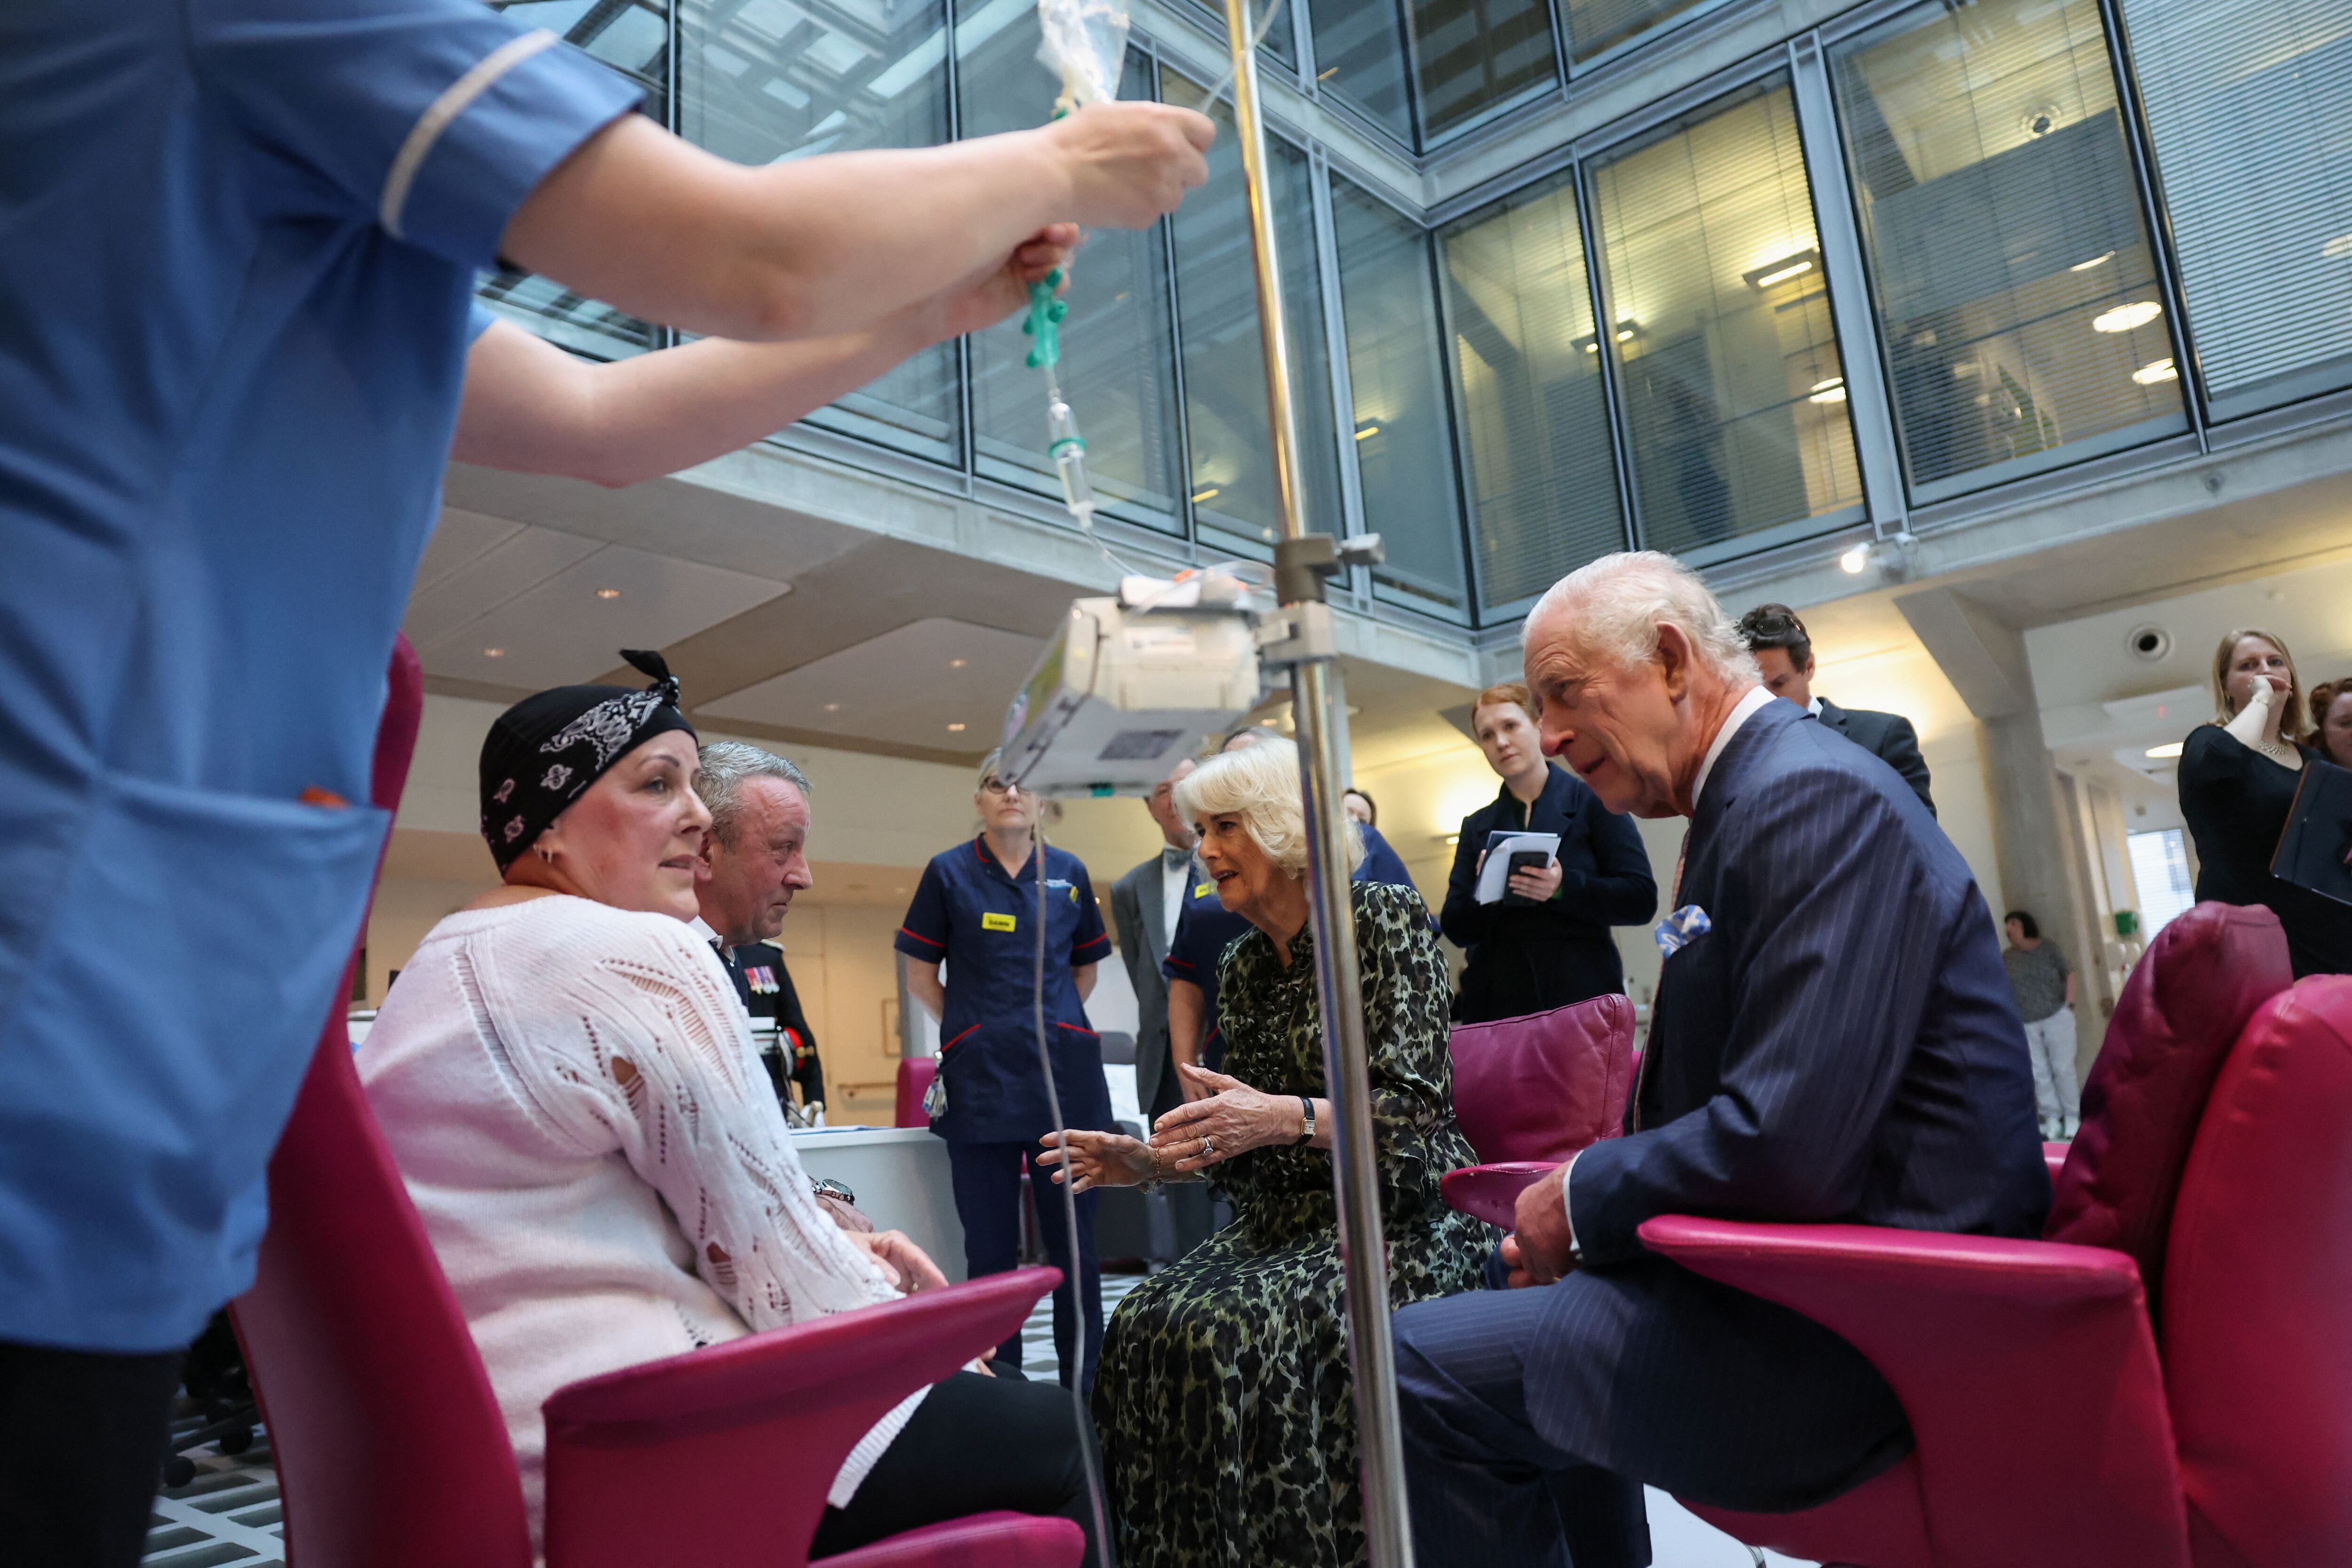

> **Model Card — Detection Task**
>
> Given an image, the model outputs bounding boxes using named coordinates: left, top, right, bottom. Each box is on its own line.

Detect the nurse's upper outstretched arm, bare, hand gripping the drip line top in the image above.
left=499, top=103, right=1216, bottom=341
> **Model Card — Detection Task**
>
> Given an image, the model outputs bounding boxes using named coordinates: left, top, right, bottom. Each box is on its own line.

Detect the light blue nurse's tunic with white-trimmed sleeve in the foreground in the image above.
left=0, top=0, right=637, bottom=1352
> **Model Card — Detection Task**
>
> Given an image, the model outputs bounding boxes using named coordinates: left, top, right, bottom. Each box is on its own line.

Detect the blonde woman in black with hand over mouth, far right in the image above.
left=2178, top=628, right=2352, bottom=980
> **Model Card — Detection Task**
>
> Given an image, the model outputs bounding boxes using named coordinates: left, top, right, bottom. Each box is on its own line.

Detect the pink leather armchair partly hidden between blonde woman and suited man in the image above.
left=1439, top=992, right=1632, bottom=1229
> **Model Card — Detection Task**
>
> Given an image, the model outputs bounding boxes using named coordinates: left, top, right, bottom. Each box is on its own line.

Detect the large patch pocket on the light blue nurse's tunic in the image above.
left=0, top=778, right=390, bottom=1352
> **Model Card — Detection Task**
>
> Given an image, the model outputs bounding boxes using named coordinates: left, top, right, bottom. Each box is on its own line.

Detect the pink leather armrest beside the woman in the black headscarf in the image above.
left=543, top=1269, right=1061, bottom=1568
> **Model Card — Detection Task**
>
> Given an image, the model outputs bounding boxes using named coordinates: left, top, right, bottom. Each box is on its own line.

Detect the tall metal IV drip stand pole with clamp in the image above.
left=1225, top=0, right=1414, bottom=1568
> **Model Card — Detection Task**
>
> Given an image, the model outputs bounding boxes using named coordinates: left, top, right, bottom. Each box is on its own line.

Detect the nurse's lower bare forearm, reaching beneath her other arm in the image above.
left=452, top=226, right=1077, bottom=487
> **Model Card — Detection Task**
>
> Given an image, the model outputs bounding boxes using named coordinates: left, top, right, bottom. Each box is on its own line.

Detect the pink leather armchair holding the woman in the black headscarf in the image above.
left=233, top=642, right=1084, bottom=1568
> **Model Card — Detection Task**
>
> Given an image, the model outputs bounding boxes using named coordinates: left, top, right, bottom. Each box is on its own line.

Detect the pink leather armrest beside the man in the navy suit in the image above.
left=1642, top=1215, right=2190, bottom=1568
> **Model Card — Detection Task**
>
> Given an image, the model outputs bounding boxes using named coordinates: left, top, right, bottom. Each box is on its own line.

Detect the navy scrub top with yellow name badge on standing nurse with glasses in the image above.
left=898, top=837, right=1110, bottom=1142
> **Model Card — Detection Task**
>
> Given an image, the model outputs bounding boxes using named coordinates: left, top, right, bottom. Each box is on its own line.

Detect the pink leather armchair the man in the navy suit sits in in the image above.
left=1642, top=905, right=2352, bottom=1568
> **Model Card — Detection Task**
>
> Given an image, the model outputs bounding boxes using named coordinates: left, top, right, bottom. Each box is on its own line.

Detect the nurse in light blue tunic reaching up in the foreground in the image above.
left=0, top=0, right=1216, bottom=1566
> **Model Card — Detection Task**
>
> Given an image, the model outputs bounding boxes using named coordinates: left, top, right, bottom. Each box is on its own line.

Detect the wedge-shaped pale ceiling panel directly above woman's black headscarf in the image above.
left=402, top=508, right=790, bottom=701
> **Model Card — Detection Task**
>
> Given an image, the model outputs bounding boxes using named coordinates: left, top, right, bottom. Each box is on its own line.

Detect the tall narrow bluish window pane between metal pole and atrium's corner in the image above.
left=1331, top=176, right=1470, bottom=618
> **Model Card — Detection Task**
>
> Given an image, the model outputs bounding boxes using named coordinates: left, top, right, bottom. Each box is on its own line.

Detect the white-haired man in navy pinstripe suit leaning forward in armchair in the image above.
left=1397, top=553, right=2051, bottom=1568
